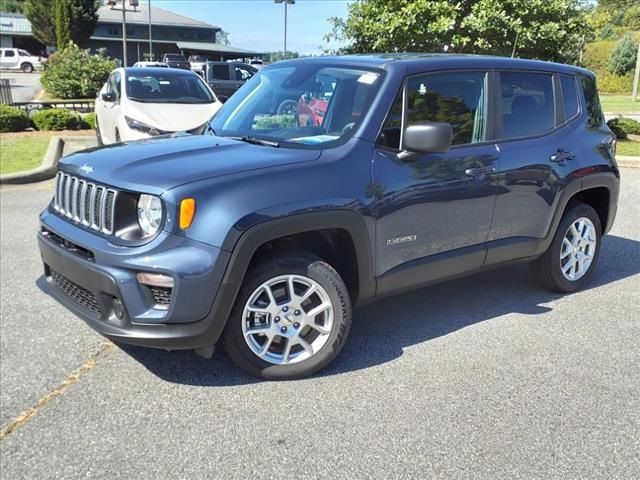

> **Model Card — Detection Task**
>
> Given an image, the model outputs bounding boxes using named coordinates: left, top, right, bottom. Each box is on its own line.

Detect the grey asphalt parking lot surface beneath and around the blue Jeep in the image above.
left=0, top=169, right=640, bottom=479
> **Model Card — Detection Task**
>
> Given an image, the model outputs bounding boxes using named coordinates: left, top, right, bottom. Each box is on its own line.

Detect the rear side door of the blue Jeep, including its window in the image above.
left=487, top=71, right=580, bottom=264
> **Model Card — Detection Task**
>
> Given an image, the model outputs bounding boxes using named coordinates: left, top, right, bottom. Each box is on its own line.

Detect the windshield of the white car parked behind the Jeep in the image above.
left=126, top=69, right=215, bottom=104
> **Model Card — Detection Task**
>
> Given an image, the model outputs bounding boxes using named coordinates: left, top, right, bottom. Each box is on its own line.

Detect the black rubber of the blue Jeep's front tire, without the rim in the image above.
left=222, top=252, right=351, bottom=380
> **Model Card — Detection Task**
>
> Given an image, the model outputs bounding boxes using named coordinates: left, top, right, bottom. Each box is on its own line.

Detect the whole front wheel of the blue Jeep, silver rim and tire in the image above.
left=223, top=253, right=351, bottom=380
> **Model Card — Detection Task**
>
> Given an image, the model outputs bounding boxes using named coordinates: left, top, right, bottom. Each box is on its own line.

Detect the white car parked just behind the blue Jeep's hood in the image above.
left=95, top=67, right=222, bottom=144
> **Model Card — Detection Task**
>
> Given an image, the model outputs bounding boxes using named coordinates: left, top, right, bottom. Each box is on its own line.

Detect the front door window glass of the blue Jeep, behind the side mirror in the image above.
left=378, top=71, right=488, bottom=149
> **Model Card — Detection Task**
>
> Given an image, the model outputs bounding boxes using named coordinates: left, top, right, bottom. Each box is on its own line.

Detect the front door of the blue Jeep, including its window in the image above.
left=367, top=70, right=498, bottom=293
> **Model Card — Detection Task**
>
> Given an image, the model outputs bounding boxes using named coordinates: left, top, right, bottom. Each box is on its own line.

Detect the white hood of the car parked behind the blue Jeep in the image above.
left=125, top=101, right=222, bottom=132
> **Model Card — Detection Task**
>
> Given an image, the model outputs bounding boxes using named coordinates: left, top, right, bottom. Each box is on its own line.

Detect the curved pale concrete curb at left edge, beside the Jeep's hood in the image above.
left=0, top=136, right=95, bottom=185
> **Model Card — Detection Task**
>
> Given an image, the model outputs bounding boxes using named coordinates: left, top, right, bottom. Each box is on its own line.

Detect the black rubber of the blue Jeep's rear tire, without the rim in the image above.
left=531, top=203, right=602, bottom=293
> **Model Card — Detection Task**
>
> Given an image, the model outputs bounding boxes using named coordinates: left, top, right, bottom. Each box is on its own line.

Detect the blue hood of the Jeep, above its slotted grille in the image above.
left=59, top=134, right=322, bottom=195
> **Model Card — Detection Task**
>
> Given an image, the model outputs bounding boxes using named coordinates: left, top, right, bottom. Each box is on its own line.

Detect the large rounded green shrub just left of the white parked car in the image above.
left=40, top=44, right=116, bottom=98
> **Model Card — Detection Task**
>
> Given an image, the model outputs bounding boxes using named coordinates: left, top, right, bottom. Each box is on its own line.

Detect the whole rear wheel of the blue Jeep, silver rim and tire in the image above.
left=531, top=203, right=602, bottom=292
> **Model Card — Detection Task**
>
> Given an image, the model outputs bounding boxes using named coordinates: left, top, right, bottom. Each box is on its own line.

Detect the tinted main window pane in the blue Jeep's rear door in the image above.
left=500, top=72, right=555, bottom=138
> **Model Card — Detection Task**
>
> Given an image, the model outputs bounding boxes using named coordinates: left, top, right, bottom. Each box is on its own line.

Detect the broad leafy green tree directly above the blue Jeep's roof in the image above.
left=325, top=0, right=590, bottom=61
